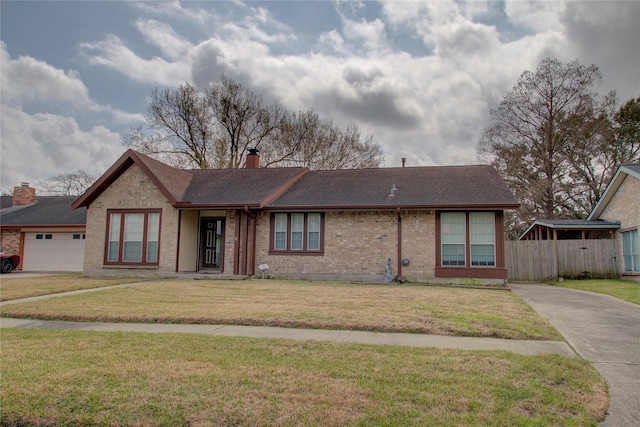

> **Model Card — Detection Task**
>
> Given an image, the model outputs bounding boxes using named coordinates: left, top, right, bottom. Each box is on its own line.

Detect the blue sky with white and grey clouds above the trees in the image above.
left=0, top=0, right=640, bottom=189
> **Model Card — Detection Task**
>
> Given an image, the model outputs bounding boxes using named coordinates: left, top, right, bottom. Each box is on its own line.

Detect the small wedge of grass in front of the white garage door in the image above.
left=0, top=274, right=144, bottom=301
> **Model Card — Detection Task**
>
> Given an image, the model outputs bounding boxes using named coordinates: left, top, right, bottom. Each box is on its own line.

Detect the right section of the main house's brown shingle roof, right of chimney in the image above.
left=271, top=166, right=518, bottom=208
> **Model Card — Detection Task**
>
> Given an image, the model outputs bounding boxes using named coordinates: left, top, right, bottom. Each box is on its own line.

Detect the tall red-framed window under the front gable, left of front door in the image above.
left=106, top=210, right=160, bottom=265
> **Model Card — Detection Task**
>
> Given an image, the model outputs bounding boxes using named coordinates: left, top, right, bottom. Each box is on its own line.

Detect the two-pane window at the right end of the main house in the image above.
left=440, top=212, right=496, bottom=267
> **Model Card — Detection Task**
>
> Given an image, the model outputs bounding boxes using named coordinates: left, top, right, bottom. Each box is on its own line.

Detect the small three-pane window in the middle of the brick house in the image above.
left=271, top=213, right=324, bottom=254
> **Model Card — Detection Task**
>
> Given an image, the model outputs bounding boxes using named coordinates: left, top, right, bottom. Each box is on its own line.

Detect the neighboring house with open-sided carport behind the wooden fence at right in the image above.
left=520, top=164, right=640, bottom=279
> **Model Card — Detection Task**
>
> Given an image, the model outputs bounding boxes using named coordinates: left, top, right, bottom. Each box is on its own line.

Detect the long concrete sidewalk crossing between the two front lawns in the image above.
left=0, top=318, right=577, bottom=357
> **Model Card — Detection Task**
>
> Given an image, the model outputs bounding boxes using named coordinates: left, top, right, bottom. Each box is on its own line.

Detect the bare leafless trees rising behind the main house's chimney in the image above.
left=122, top=77, right=384, bottom=169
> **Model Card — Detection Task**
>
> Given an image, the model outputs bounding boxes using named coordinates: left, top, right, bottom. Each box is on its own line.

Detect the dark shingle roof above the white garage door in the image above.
left=0, top=196, right=87, bottom=226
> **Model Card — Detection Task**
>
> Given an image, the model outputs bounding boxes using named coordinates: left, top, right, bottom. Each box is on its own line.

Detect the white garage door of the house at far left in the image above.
left=22, top=233, right=85, bottom=271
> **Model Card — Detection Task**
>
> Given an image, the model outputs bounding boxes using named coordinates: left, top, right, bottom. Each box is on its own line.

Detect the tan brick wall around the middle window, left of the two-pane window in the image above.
left=256, top=211, right=435, bottom=280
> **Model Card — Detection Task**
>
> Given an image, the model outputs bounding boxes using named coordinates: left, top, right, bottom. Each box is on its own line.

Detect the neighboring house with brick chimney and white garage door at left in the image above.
left=0, top=184, right=87, bottom=272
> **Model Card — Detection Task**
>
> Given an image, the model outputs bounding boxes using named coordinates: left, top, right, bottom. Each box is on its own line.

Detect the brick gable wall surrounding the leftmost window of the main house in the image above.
left=84, top=165, right=178, bottom=275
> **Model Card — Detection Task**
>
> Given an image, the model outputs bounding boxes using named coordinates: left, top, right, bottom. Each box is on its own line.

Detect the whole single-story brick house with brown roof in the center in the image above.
left=73, top=150, right=518, bottom=282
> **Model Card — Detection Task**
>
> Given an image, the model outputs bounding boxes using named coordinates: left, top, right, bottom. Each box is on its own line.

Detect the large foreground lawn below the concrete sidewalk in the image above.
left=0, top=329, right=608, bottom=426
